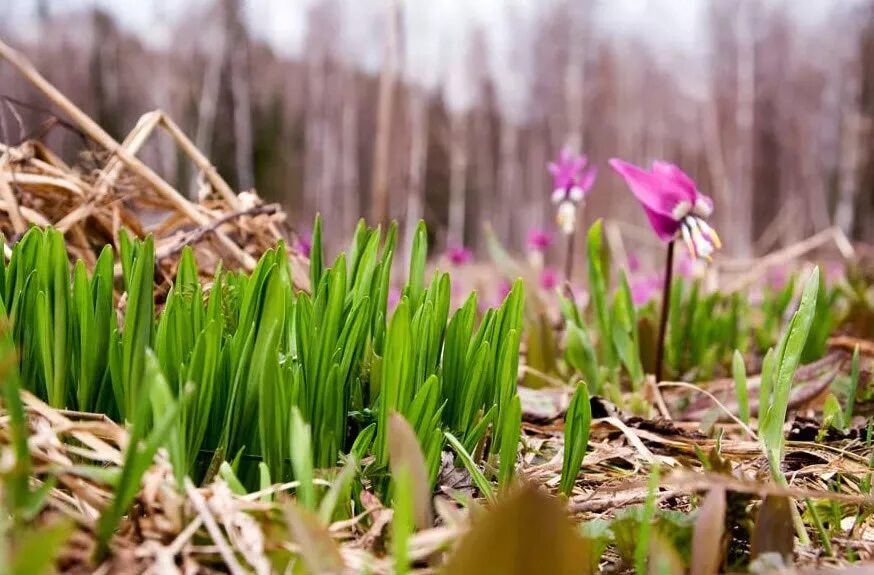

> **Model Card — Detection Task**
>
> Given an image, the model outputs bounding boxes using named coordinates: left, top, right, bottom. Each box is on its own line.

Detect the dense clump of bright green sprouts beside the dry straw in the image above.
left=0, top=219, right=524, bottom=560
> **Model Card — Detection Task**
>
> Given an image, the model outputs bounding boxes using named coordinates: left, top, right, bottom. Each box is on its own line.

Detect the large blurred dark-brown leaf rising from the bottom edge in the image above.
left=441, top=484, right=592, bottom=575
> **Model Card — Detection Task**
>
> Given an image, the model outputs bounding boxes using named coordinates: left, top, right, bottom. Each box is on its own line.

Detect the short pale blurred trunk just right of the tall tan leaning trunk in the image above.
left=404, top=86, right=428, bottom=264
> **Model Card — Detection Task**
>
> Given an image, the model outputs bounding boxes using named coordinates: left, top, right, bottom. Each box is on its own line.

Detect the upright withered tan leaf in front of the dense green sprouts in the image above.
left=388, top=412, right=433, bottom=529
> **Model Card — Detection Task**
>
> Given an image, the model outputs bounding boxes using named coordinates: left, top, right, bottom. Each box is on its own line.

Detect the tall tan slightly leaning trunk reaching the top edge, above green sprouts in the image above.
left=371, top=0, right=400, bottom=223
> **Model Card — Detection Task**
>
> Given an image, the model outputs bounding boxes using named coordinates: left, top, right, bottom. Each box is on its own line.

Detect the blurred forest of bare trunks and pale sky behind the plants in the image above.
left=0, top=0, right=874, bottom=270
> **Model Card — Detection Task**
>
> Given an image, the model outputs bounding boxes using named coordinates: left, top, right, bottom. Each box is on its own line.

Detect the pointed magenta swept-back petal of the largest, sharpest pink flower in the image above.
left=610, top=158, right=695, bottom=218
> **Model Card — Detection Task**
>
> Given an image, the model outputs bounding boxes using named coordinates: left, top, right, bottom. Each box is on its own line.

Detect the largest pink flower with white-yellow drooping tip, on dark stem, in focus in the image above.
left=610, top=158, right=722, bottom=260
